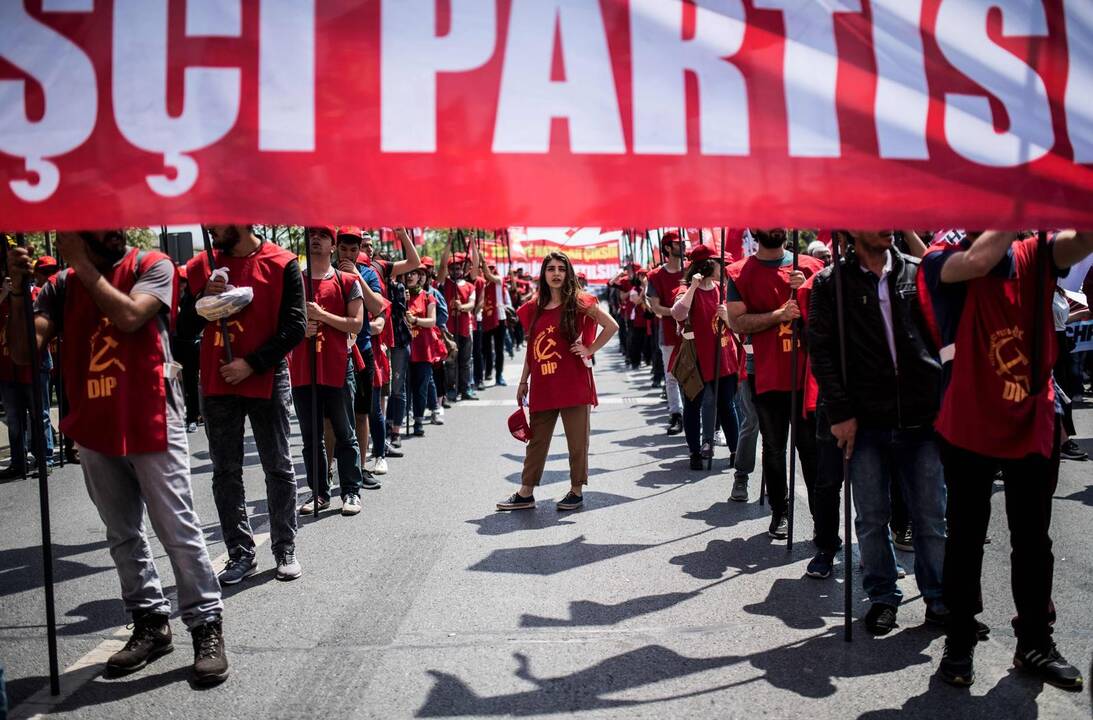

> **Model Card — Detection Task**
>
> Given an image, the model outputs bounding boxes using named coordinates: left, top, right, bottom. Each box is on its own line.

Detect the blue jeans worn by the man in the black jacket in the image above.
left=850, top=428, right=945, bottom=605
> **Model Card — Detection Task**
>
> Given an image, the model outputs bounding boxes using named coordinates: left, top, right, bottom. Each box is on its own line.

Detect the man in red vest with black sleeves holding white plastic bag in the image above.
left=187, top=225, right=307, bottom=586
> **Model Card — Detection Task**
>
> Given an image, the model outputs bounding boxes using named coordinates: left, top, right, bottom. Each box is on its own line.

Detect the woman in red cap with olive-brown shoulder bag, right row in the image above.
left=670, top=245, right=741, bottom=470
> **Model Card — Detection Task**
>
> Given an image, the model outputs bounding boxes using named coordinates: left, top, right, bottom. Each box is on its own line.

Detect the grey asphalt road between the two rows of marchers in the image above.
left=0, top=349, right=1093, bottom=720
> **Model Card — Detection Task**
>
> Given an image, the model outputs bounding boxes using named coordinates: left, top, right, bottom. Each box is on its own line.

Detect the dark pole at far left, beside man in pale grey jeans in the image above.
left=9, top=233, right=61, bottom=695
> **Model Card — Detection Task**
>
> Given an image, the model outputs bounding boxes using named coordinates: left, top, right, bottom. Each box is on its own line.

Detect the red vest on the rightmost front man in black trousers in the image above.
left=931, top=237, right=1057, bottom=461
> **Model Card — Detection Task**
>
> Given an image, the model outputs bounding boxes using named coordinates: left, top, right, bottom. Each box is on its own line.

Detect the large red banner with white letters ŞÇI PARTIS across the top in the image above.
left=0, top=0, right=1093, bottom=229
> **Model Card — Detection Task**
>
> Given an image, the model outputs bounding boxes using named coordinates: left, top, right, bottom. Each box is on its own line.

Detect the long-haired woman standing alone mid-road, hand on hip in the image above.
left=497, top=252, right=619, bottom=510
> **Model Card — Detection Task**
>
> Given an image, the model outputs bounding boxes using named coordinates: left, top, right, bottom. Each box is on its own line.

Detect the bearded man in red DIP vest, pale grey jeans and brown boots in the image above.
left=8, top=231, right=228, bottom=684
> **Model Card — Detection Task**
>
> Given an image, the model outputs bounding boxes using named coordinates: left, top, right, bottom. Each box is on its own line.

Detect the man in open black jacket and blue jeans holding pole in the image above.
left=808, top=232, right=947, bottom=635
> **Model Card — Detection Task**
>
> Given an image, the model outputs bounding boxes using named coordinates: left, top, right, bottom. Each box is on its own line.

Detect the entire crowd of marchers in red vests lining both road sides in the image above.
left=0, top=225, right=1093, bottom=688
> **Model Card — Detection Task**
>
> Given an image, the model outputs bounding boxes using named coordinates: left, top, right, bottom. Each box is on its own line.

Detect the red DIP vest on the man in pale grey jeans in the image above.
left=58, top=249, right=183, bottom=457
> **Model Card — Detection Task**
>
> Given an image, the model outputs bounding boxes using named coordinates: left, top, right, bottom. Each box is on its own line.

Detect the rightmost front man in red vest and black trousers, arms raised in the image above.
left=915, top=231, right=1093, bottom=691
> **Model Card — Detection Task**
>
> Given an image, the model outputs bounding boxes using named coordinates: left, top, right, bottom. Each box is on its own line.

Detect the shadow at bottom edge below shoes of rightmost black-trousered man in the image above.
left=858, top=668, right=1044, bottom=720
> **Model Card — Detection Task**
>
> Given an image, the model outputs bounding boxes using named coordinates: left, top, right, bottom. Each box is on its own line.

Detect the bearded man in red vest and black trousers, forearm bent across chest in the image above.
left=726, top=227, right=821, bottom=539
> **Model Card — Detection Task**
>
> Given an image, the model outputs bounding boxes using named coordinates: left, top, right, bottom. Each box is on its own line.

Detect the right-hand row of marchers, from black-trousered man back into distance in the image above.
left=608, top=228, right=1093, bottom=688
